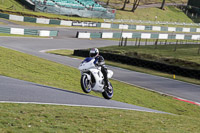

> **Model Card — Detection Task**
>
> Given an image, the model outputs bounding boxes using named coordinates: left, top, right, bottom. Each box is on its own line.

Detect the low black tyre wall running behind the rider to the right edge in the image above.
left=74, top=50, right=200, bottom=79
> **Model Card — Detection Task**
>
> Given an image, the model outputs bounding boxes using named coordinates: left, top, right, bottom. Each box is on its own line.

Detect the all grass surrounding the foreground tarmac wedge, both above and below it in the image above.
left=0, top=47, right=200, bottom=132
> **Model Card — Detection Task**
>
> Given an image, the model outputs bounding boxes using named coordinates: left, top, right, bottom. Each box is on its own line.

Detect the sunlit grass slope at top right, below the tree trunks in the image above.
left=116, top=6, right=193, bottom=23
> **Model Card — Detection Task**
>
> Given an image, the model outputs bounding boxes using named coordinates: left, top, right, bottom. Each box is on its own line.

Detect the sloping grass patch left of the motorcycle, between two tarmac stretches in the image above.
left=0, top=48, right=80, bottom=91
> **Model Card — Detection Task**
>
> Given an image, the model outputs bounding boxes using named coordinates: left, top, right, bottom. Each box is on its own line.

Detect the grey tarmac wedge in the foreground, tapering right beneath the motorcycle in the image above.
left=0, top=76, right=167, bottom=113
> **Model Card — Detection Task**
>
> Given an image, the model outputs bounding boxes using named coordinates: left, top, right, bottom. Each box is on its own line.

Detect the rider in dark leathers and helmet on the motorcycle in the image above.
left=89, top=48, right=109, bottom=87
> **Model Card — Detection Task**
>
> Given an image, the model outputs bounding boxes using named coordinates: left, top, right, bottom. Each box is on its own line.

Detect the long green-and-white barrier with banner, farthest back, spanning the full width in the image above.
left=0, top=13, right=200, bottom=33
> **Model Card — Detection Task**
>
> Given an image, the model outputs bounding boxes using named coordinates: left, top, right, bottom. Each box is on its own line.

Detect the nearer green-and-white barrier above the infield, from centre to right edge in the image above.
left=76, top=32, right=200, bottom=40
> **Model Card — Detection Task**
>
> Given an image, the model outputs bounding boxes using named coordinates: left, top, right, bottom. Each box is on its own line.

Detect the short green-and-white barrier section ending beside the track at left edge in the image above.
left=0, top=27, right=58, bottom=37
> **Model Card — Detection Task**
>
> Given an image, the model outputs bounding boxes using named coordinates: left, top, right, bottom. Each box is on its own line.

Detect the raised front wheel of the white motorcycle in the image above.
left=81, top=75, right=92, bottom=93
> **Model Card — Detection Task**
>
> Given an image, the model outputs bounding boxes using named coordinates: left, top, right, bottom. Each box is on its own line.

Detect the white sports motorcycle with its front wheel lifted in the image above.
left=79, top=57, right=113, bottom=99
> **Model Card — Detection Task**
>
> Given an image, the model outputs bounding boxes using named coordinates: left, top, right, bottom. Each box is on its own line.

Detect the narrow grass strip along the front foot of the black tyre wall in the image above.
left=48, top=50, right=200, bottom=85
